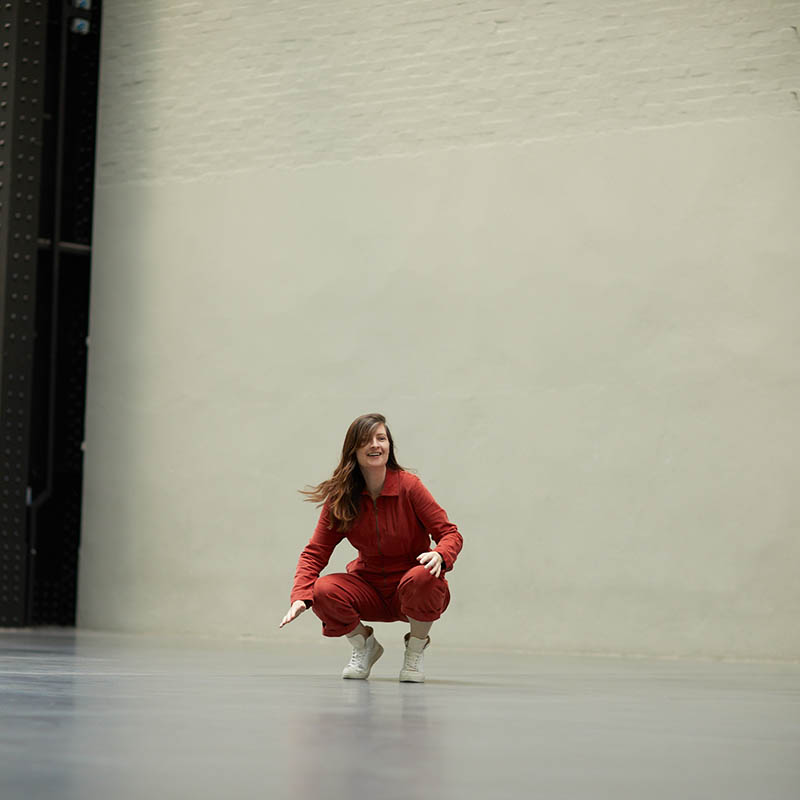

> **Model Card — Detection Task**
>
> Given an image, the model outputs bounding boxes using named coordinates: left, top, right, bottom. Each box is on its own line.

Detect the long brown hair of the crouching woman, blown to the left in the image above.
left=300, top=414, right=403, bottom=531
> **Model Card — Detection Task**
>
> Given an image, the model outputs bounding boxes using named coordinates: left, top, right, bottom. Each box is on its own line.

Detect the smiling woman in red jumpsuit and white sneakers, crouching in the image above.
left=280, top=414, right=462, bottom=683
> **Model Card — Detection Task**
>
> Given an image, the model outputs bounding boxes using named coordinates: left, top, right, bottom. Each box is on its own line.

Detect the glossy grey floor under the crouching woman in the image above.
left=0, top=627, right=800, bottom=800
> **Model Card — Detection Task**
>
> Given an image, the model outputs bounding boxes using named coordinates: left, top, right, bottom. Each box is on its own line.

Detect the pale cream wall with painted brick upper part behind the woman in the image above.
left=79, top=0, right=800, bottom=659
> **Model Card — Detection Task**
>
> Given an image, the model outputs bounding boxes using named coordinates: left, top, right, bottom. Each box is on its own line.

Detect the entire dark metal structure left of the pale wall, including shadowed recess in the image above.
left=0, top=0, right=100, bottom=627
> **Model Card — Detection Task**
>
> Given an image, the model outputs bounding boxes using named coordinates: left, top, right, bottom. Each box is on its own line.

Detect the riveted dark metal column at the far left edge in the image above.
left=0, top=0, right=47, bottom=626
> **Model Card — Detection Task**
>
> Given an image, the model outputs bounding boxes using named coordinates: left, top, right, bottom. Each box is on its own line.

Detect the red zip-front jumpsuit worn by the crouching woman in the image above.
left=290, top=469, right=463, bottom=636
